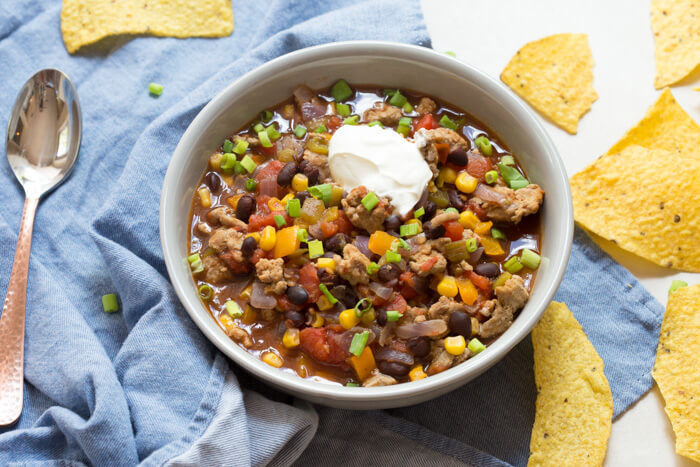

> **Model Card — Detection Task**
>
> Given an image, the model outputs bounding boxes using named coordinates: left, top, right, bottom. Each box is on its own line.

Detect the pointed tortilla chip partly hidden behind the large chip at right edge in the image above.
left=607, top=88, right=700, bottom=159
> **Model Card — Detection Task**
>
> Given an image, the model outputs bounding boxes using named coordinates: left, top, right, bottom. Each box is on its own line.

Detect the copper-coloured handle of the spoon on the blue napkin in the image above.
left=0, top=198, right=39, bottom=426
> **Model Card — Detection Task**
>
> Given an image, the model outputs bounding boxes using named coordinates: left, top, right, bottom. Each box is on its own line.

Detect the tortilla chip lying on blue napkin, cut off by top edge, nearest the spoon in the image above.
left=61, top=0, right=233, bottom=53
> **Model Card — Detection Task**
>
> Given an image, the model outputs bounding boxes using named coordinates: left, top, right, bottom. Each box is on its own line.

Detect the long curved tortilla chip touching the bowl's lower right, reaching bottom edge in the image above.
left=527, top=302, right=613, bottom=467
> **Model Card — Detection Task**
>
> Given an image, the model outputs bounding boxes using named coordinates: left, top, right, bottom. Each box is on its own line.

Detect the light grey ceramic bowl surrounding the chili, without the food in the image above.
left=160, top=41, right=573, bottom=409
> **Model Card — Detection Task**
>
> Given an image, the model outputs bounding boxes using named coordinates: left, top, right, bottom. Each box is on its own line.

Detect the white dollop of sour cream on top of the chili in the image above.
left=328, top=125, right=433, bottom=215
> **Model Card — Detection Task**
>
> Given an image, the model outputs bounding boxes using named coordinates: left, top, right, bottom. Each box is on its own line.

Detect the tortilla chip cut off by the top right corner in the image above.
left=651, top=0, right=700, bottom=89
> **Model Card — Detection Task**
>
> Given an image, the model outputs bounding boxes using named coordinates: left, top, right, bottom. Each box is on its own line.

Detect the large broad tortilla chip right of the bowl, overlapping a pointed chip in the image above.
left=570, top=146, right=700, bottom=272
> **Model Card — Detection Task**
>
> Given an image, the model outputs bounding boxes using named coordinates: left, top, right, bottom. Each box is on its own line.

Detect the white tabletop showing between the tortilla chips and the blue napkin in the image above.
left=422, top=0, right=700, bottom=467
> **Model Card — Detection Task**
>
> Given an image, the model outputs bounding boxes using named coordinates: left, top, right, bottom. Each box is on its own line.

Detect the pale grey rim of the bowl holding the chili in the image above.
left=159, top=41, right=574, bottom=402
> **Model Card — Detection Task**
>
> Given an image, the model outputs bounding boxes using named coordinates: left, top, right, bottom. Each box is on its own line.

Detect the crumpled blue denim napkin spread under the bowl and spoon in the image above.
left=0, top=0, right=663, bottom=466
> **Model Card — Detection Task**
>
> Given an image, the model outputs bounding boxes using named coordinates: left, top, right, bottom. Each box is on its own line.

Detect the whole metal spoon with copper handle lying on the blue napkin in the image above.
left=0, top=69, right=81, bottom=426
